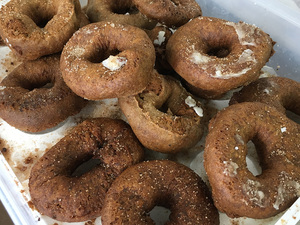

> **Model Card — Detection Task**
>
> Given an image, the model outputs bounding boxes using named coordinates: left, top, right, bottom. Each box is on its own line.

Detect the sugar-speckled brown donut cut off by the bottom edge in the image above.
left=101, top=160, right=219, bottom=225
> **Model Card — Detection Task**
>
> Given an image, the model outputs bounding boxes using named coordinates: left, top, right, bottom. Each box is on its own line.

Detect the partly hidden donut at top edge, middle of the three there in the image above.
left=86, top=0, right=157, bottom=29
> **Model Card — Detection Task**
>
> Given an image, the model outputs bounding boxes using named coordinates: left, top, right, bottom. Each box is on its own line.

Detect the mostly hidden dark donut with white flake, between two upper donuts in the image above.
left=146, top=25, right=173, bottom=74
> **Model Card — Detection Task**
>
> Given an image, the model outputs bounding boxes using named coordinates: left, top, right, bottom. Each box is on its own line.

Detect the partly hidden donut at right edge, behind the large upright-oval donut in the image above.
left=229, top=77, right=300, bottom=115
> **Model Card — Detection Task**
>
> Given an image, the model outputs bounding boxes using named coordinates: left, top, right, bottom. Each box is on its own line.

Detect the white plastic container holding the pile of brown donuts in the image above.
left=0, top=0, right=300, bottom=225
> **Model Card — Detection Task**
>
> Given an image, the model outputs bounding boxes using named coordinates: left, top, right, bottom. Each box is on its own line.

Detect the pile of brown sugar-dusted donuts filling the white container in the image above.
left=0, top=0, right=300, bottom=225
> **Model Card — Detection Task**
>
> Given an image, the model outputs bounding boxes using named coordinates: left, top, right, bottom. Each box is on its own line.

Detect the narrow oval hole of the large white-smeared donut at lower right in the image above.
left=246, top=141, right=262, bottom=176
